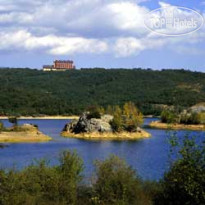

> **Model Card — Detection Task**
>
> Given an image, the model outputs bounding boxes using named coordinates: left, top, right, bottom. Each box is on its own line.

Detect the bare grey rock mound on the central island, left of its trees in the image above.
left=63, top=113, right=113, bottom=134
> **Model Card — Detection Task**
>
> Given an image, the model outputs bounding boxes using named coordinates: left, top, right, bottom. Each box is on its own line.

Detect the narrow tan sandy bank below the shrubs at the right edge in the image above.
left=148, top=121, right=205, bottom=131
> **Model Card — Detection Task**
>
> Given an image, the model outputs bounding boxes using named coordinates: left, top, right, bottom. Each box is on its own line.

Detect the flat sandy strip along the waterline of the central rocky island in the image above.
left=61, top=130, right=151, bottom=141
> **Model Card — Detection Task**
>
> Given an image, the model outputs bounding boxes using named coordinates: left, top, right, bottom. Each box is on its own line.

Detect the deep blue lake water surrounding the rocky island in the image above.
left=0, top=118, right=205, bottom=180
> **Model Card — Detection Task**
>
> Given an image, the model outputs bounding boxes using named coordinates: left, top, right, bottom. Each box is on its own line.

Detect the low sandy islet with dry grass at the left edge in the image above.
left=0, top=118, right=52, bottom=143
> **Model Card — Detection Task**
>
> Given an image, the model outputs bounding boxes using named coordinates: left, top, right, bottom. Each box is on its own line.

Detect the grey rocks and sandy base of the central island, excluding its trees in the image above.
left=61, top=113, right=151, bottom=140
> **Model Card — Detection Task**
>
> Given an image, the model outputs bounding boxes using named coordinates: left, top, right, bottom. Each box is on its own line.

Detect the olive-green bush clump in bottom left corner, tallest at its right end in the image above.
left=0, top=151, right=83, bottom=205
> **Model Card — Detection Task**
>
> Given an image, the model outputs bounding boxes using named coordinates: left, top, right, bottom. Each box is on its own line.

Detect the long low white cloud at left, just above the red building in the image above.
left=0, top=30, right=107, bottom=55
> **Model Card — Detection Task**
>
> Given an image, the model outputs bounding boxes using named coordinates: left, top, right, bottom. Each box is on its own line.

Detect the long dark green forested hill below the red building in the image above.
left=0, top=69, right=205, bottom=115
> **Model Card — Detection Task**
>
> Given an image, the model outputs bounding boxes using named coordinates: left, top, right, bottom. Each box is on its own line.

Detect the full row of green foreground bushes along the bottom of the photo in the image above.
left=0, top=136, right=205, bottom=205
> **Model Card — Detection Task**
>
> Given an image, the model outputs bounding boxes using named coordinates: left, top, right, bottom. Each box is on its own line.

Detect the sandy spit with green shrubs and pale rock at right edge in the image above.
left=149, top=103, right=205, bottom=131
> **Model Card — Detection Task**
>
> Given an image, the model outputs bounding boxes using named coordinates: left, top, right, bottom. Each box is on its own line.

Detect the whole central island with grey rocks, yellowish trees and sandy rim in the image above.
left=61, top=102, right=151, bottom=140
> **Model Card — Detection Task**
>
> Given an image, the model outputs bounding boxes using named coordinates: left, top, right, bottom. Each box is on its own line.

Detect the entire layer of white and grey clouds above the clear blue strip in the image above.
left=0, top=0, right=205, bottom=57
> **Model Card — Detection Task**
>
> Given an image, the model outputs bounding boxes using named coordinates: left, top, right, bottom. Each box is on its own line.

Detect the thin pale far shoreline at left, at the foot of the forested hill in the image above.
left=0, top=115, right=79, bottom=120
